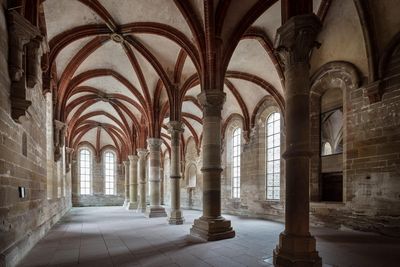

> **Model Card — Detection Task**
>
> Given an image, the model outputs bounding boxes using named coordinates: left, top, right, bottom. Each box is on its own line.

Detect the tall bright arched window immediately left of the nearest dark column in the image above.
left=266, top=112, right=281, bottom=200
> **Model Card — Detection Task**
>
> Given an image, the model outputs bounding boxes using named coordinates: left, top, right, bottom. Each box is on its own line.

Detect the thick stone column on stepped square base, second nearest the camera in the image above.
left=190, top=90, right=235, bottom=241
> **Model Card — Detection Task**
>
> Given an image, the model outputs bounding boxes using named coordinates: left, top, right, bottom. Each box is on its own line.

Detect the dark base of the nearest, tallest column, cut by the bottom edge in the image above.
left=274, top=233, right=322, bottom=267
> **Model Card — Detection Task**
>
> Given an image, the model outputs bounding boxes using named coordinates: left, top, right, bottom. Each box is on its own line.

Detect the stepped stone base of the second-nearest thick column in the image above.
left=190, top=217, right=235, bottom=241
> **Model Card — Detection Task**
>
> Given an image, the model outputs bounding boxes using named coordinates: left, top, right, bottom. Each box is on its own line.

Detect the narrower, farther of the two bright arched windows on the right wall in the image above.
left=232, top=128, right=242, bottom=198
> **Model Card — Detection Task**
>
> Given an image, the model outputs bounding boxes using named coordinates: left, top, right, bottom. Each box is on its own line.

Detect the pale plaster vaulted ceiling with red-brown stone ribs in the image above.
left=42, top=0, right=330, bottom=161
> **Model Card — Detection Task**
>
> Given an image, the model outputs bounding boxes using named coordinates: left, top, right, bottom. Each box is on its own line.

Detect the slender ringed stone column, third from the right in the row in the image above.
left=168, top=121, right=183, bottom=224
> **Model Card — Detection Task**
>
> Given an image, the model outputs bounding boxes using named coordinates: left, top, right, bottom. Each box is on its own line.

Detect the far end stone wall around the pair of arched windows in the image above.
left=72, top=157, right=125, bottom=207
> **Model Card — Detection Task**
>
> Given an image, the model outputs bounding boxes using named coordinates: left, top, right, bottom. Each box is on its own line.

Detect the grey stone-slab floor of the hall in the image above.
left=20, top=207, right=400, bottom=267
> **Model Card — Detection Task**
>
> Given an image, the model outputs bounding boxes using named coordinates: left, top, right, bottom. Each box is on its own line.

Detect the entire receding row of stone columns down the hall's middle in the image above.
left=118, top=11, right=322, bottom=266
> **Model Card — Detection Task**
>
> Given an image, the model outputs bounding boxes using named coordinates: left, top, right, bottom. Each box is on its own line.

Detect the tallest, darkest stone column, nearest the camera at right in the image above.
left=274, top=14, right=322, bottom=267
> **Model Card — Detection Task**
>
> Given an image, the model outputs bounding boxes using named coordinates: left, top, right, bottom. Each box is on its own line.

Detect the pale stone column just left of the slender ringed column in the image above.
left=146, top=138, right=167, bottom=218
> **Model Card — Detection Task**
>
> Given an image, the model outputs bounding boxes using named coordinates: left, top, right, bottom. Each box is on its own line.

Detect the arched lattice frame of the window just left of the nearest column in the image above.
left=265, top=111, right=282, bottom=201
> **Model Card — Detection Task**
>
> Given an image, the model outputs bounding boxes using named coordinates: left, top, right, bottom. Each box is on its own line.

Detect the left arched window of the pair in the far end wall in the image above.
left=79, top=148, right=92, bottom=195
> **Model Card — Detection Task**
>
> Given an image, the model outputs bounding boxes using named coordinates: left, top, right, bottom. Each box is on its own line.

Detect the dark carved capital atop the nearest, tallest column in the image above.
left=274, top=14, right=322, bottom=70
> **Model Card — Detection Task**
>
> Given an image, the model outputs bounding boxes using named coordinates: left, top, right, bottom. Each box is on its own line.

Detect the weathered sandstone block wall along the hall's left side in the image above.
left=0, top=1, right=71, bottom=266
